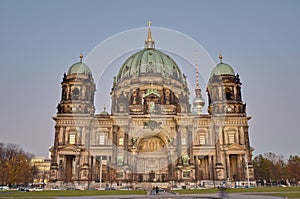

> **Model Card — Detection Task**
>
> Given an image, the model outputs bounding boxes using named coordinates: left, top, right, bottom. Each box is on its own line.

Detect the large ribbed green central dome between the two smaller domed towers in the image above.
left=116, top=48, right=182, bottom=81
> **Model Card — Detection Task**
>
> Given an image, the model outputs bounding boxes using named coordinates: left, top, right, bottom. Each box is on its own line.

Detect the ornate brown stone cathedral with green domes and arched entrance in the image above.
left=50, top=25, right=254, bottom=188
